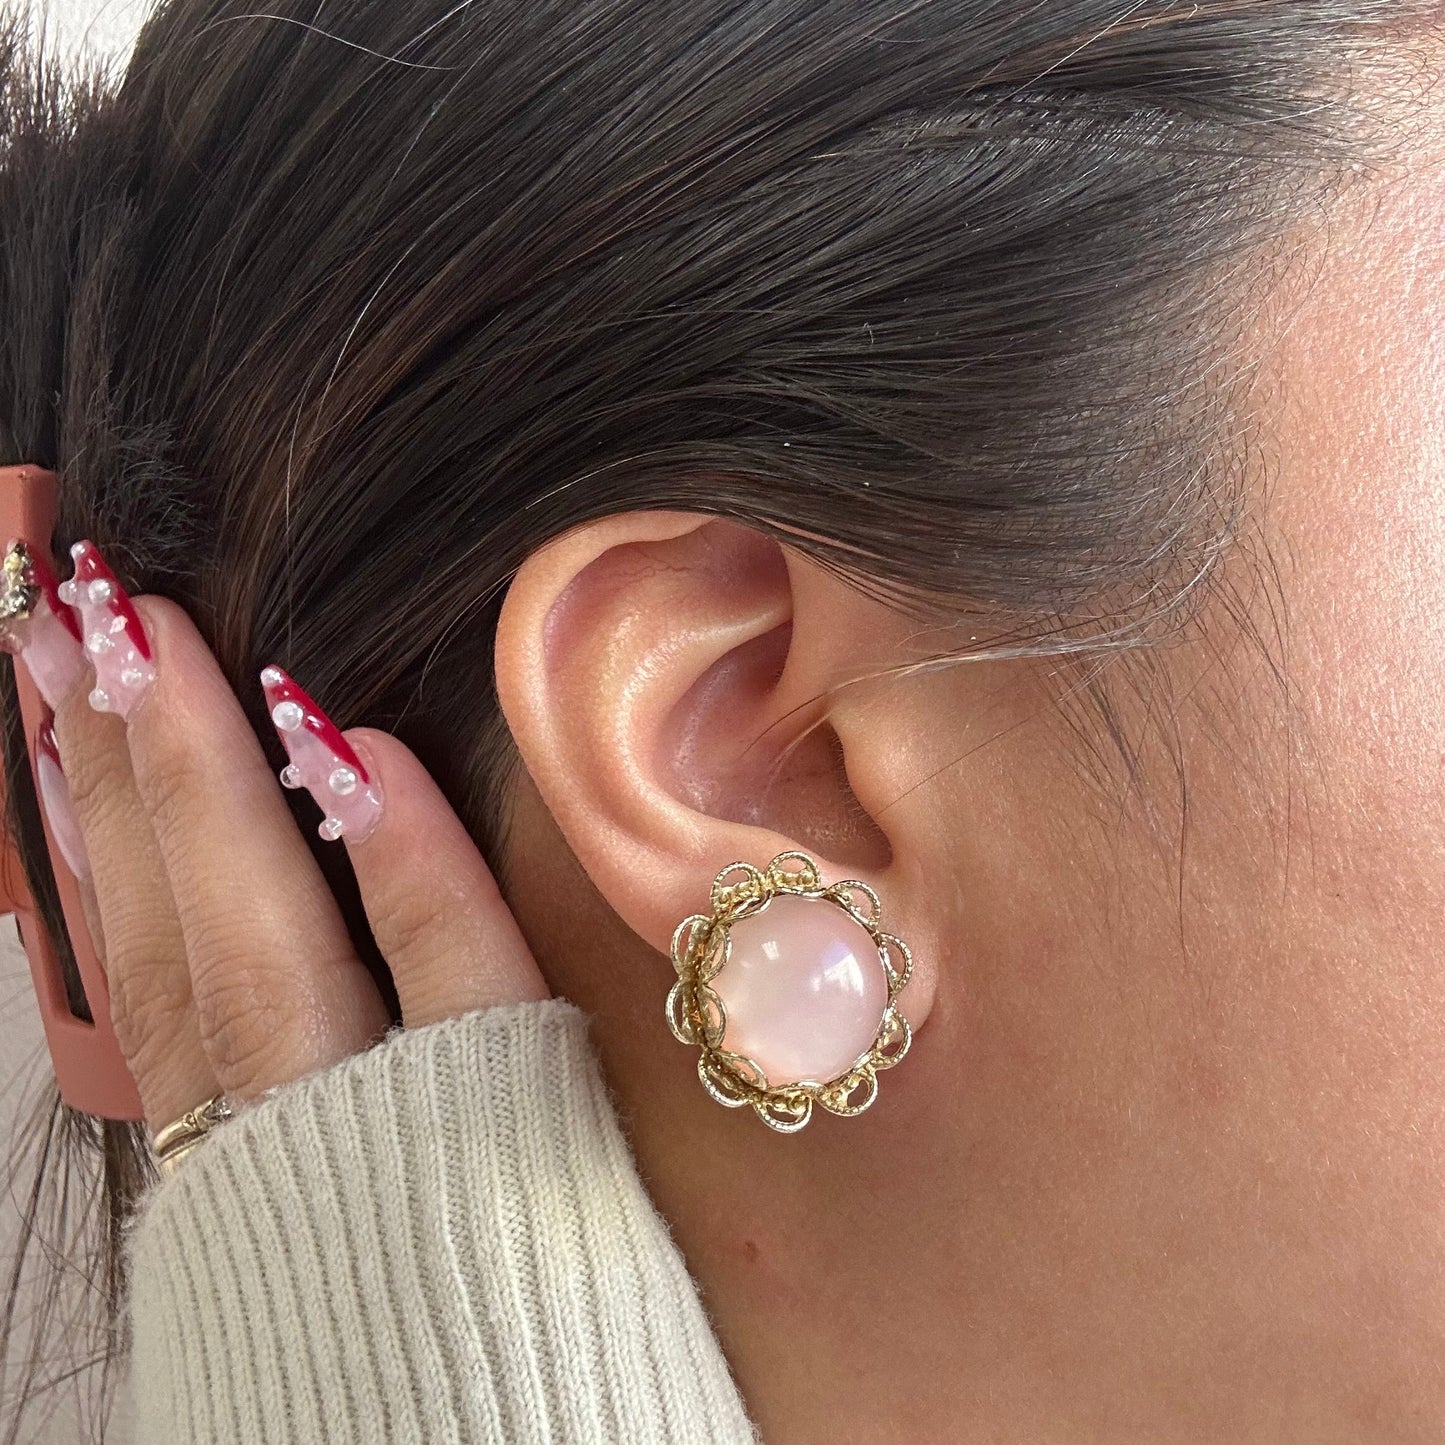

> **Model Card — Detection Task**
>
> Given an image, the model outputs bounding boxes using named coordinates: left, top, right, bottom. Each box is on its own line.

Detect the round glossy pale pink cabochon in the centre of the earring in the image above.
left=711, top=893, right=889, bottom=1087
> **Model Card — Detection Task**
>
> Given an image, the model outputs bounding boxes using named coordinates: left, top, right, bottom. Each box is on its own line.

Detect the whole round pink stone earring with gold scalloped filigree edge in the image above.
left=668, top=851, right=913, bottom=1134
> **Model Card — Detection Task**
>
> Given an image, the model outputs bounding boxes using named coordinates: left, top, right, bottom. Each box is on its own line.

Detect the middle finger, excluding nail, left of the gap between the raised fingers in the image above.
left=101, top=583, right=390, bottom=1098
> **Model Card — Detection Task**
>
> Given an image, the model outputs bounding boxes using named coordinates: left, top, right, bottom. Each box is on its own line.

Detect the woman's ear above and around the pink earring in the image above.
left=496, top=512, right=936, bottom=1025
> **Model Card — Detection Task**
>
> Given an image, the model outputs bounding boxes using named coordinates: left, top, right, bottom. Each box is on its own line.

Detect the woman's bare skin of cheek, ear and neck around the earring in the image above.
left=485, top=65, right=1445, bottom=1442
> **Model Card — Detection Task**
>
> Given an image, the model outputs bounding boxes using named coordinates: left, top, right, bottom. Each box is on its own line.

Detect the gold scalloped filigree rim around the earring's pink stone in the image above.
left=668, top=850, right=913, bottom=1134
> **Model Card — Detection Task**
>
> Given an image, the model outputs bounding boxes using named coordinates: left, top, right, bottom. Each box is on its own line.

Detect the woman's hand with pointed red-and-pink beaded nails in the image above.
left=45, top=549, right=548, bottom=1127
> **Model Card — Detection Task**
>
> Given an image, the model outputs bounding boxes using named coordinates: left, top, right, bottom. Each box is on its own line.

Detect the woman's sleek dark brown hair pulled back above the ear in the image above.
left=0, top=0, right=1406, bottom=1439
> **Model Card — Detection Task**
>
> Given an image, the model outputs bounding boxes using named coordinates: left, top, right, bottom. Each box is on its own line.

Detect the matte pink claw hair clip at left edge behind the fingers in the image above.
left=0, top=464, right=143, bottom=1120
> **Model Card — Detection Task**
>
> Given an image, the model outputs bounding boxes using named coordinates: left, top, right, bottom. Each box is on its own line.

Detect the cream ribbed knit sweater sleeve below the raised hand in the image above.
left=118, top=1000, right=757, bottom=1445
